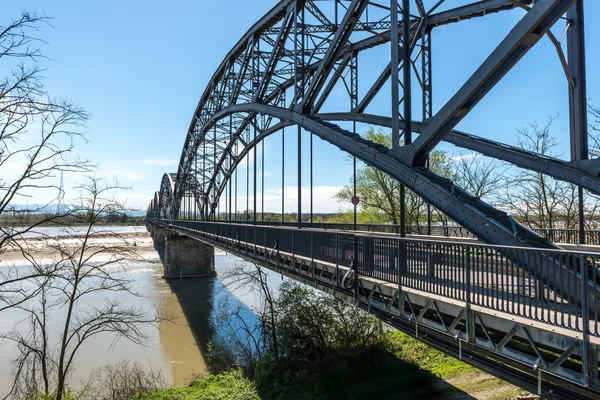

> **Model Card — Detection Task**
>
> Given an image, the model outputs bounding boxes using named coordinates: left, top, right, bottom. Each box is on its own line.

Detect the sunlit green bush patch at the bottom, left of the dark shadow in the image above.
left=133, top=370, right=260, bottom=400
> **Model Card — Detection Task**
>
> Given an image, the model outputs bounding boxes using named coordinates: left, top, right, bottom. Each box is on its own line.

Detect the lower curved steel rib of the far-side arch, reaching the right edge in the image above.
left=317, top=113, right=600, bottom=194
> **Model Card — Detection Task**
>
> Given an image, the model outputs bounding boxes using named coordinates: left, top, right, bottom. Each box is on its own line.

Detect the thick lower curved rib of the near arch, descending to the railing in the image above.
left=191, top=104, right=557, bottom=248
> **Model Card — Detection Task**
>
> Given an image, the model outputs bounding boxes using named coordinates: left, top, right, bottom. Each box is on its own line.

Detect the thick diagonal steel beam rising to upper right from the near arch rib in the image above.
left=396, top=0, right=575, bottom=166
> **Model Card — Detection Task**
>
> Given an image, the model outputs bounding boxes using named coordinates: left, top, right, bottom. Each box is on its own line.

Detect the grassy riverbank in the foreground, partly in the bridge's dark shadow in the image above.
left=134, top=332, right=537, bottom=400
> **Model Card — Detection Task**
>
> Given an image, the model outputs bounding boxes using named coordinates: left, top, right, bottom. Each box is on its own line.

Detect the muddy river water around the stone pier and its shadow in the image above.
left=0, top=233, right=280, bottom=397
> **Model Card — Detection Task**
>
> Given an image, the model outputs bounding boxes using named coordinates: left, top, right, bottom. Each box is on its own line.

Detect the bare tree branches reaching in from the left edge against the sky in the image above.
left=0, top=12, right=91, bottom=310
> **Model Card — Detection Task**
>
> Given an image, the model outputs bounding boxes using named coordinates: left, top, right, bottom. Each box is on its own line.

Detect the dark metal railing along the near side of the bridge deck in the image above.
left=154, top=220, right=600, bottom=336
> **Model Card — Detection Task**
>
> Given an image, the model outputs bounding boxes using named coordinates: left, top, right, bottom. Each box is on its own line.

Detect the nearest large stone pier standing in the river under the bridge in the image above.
left=163, top=232, right=217, bottom=279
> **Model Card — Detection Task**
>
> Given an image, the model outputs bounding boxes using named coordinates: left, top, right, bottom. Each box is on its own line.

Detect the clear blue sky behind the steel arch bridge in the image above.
left=0, top=0, right=600, bottom=211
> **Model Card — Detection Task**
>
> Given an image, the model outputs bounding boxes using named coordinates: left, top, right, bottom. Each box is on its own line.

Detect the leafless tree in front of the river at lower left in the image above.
left=4, top=177, right=161, bottom=400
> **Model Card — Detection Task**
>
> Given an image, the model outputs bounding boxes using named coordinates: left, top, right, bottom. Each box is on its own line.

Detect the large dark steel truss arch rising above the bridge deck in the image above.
left=154, top=0, right=600, bottom=248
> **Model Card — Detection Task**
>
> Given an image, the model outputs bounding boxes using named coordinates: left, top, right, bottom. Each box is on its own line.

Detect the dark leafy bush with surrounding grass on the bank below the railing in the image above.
left=135, top=282, right=520, bottom=400
